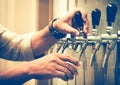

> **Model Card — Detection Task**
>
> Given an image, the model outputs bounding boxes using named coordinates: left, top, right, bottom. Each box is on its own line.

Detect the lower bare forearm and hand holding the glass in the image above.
left=0, top=53, right=80, bottom=85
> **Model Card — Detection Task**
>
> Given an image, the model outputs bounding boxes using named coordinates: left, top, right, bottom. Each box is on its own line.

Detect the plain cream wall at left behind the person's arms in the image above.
left=0, top=0, right=37, bottom=85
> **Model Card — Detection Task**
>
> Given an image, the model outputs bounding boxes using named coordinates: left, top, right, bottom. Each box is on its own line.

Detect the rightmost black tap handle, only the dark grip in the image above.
left=106, top=3, right=117, bottom=26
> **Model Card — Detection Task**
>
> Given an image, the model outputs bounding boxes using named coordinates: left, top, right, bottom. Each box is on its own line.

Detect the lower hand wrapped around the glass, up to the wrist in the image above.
left=29, top=53, right=79, bottom=81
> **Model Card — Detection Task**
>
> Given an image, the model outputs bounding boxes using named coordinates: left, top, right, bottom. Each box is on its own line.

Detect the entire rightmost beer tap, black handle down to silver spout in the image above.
left=102, top=4, right=117, bottom=68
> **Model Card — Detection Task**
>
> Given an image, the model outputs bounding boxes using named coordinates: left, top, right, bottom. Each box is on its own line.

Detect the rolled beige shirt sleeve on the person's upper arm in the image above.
left=0, top=25, right=34, bottom=61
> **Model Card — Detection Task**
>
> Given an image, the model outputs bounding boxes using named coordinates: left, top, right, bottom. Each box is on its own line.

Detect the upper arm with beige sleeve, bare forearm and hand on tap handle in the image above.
left=0, top=9, right=89, bottom=60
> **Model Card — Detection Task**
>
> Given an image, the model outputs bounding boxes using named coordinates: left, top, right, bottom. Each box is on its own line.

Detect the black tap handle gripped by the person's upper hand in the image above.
left=74, top=12, right=84, bottom=30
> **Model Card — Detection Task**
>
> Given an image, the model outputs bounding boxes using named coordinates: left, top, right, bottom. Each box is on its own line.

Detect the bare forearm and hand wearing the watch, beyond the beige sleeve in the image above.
left=31, top=8, right=89, bottom=56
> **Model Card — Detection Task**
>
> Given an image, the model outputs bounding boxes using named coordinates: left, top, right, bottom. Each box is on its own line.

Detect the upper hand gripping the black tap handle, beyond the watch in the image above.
left=53, top=8, right=89, bottom=36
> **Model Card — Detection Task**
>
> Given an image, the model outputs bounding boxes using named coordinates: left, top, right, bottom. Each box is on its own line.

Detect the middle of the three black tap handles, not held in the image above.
left=91, top=9, right=101, bottom=29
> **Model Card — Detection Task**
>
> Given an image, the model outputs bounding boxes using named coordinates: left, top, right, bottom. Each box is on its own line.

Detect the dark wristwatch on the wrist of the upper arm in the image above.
left=49, top=18, right=66, bottom=39
